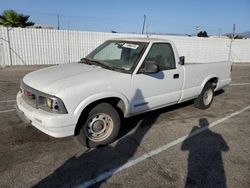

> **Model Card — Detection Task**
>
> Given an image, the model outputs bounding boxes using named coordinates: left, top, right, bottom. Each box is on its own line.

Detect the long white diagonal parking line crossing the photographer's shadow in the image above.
left=77, top=105, right=250, bottom=188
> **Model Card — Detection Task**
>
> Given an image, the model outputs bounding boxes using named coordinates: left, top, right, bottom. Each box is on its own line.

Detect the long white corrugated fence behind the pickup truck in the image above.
left=0, top=27, right=250, bottom=65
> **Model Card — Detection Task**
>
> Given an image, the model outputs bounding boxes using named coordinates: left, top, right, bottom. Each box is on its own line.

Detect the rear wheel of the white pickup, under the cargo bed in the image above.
left=194, top=82, right=214, bottom=109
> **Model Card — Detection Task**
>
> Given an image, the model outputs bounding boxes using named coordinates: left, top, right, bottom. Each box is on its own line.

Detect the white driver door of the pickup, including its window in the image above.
left=131, top=43, right=183, bottom=114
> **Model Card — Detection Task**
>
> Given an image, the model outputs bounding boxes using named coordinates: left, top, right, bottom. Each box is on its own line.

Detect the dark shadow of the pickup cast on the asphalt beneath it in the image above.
left=34, top=90, right=225, bottom=187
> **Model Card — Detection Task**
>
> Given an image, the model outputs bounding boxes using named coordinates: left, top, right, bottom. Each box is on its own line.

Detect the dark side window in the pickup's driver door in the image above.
left=145, top=43, right=176, bottom=70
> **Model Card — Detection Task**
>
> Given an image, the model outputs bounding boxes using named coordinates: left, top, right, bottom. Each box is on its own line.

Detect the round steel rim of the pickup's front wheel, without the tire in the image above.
left=86, top=113, right=113, bottom=142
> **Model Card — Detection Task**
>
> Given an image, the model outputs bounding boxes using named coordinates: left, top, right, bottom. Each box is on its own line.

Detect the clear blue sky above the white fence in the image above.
left=0, top=0, right=250, bottom=35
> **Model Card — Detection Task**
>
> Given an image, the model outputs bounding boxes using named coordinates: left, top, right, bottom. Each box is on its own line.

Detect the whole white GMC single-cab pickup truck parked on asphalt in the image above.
left=16, top=38, right=232, bottom=147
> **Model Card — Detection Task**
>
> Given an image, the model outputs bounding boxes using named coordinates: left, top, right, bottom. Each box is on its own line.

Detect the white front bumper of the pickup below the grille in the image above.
left=16, top=92, right=78, bottom=138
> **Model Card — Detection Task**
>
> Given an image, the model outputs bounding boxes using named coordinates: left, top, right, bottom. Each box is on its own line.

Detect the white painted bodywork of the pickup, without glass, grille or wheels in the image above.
left=17, top=38, right=231, bottom=137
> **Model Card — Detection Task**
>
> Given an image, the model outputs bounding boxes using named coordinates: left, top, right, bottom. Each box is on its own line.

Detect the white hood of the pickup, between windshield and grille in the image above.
left=23, top=63, right=121, bottom=95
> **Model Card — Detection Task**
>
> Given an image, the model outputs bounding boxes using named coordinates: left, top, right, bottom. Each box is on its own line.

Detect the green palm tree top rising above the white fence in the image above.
left=0, top=10, right=34, bottom=27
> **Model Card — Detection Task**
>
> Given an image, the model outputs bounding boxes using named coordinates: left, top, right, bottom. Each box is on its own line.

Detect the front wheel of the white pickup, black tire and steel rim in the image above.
left=78, top=103, right=121, bottom=148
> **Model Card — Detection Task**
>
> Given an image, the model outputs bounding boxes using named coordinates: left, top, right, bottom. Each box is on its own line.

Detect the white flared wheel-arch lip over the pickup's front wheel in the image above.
left=74, top=91, right=129, bottom=117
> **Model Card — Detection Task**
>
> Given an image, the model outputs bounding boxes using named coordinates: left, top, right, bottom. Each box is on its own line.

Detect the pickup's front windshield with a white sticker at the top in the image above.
left=86, top=40, right=147, bottom=73
